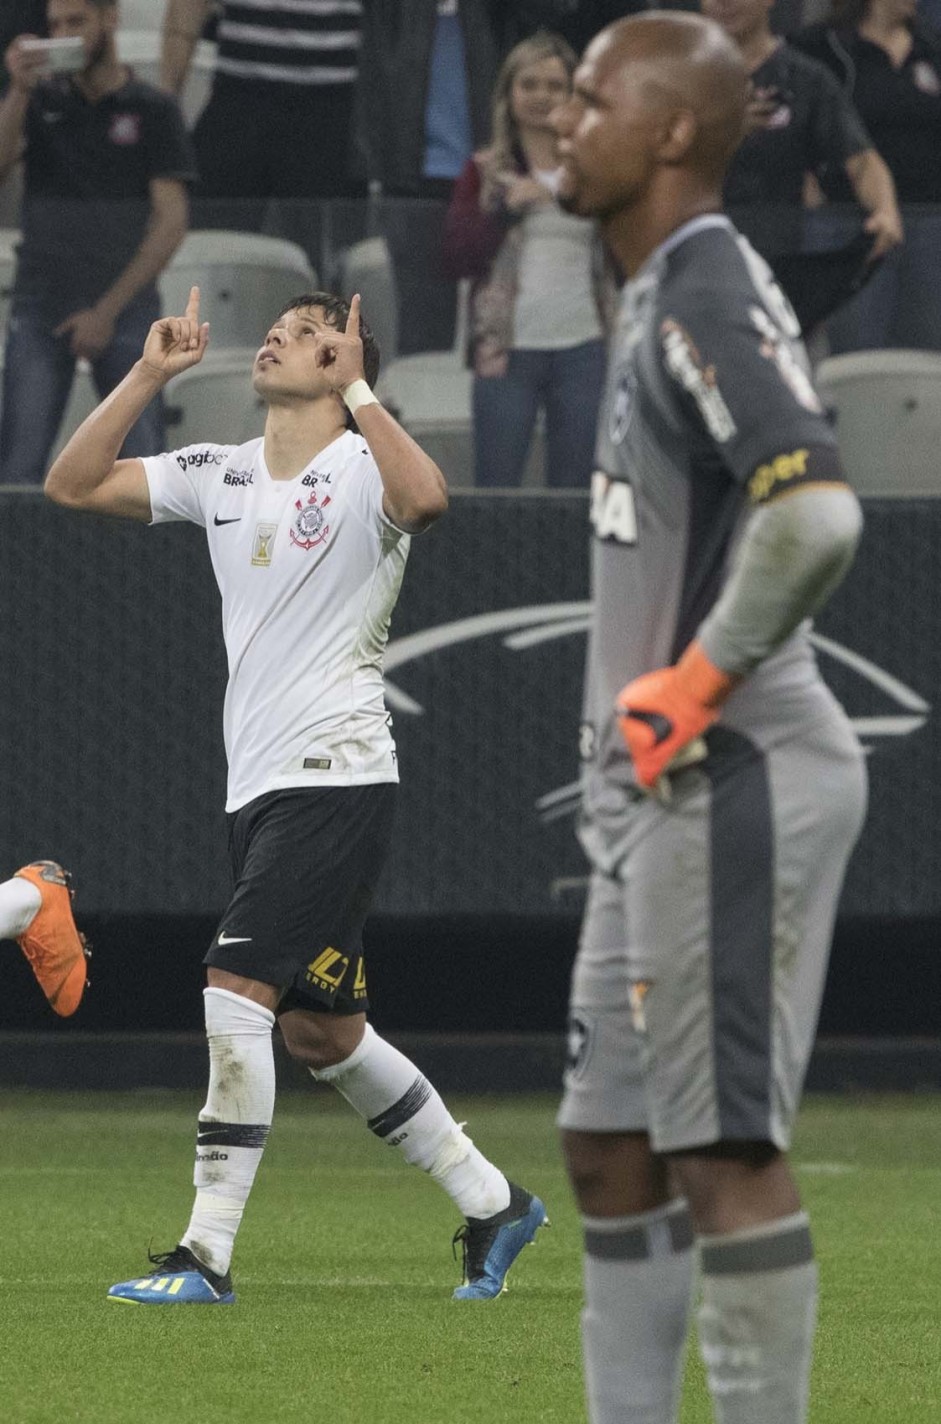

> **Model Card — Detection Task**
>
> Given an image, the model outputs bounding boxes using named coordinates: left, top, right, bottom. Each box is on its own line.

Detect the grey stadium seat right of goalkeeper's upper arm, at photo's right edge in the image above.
left=816, top=350, right=941, bottom=497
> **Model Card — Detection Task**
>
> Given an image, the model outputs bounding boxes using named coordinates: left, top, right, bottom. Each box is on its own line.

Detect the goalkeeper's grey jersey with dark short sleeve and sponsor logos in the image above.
left=581, top=214, right=853, bottom=869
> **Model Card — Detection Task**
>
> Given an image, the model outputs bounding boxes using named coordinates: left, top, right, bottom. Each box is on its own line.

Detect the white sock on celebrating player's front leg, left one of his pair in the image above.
left=182, top=988, right=275, bottom=1276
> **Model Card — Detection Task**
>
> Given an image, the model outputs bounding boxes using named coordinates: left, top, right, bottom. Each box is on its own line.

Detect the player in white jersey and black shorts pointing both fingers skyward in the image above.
left=46, top=277, right=545, bottom=1304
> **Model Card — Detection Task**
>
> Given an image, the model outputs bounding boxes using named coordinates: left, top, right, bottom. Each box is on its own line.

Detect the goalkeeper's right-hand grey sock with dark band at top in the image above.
left=699, top=1212, right=817, bottom=1424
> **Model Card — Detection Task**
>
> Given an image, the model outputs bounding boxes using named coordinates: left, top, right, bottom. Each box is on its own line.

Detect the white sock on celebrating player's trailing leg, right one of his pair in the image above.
left=310, top=1024, right=510, bottom=1218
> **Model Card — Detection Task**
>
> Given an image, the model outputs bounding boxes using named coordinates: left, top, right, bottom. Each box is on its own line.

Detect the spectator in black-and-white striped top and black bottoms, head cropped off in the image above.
left=161, top=0, right=363, bottom=228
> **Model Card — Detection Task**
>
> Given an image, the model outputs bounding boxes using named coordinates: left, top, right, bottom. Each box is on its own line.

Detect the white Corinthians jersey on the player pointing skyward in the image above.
left=142, top=430, right=410, bottom=810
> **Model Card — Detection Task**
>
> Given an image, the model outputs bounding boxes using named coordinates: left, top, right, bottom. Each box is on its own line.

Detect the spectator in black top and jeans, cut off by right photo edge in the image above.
left=794, top=0, right=941, bottom=352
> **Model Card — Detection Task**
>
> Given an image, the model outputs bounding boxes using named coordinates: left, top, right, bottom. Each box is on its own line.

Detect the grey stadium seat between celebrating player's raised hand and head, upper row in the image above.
left=159, top=229, right=316, bottom=349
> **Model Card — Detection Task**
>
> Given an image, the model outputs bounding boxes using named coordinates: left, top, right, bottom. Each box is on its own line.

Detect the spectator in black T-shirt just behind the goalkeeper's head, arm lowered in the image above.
left=700, top=0, right=903, bottom=265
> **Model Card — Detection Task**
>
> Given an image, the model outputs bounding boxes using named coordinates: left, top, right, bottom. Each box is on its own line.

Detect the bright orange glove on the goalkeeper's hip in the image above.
left=616, top=639, right=739, bottom=790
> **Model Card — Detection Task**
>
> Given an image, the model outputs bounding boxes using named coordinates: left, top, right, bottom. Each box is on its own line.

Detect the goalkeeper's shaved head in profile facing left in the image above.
left=554, top=11, right=747, bottom=269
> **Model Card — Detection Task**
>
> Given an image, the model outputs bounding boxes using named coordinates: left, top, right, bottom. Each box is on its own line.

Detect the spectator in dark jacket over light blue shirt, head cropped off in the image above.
left=356, top=0, right=498, bottom=355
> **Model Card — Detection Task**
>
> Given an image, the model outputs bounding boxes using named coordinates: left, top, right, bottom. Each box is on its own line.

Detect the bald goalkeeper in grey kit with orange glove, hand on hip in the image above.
left=555, top=11, right=866, bottom=1424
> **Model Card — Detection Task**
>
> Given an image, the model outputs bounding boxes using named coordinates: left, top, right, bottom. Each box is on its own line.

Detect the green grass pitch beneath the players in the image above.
left=0, top=1091, right=941, bottom=1424
